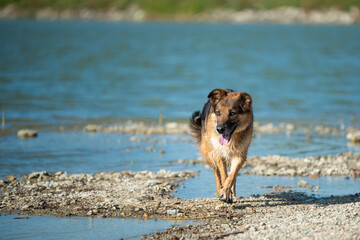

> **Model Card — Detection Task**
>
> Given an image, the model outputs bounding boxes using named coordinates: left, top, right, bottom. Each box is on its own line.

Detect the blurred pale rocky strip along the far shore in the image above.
left=0, top=4, right=360, bottom=25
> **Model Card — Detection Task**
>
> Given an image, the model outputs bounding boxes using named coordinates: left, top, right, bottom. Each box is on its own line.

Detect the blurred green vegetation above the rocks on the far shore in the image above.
left=0, top=0, right=360, bottom=14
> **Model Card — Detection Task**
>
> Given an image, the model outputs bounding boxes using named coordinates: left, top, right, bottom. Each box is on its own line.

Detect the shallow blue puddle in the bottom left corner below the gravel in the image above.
left=0, top=215, right=191, bottom=240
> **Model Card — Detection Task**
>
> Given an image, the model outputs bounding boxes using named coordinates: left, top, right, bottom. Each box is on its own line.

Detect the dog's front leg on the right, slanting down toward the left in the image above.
left=219, top=157, right=246, bottom=203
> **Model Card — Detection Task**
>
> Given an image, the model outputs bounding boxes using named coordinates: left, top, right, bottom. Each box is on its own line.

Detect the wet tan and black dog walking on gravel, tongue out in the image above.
left=190, top=89, right=254, bottom=203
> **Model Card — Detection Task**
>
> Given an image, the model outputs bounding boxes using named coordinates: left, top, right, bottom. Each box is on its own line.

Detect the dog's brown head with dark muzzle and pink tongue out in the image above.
left=208, top=89, right=253, bottom=145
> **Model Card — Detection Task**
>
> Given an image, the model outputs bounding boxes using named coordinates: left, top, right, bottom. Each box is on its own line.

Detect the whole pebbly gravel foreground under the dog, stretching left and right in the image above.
left=0, top=170, right=360, bottom=239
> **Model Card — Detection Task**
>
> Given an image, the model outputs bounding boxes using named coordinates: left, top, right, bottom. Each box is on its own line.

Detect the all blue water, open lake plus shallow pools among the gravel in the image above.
left=0, top=20, right=360, bottom=239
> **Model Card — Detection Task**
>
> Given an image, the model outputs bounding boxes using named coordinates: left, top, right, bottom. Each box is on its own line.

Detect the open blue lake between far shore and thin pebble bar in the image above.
left=0, top=21, right=360, bottom=127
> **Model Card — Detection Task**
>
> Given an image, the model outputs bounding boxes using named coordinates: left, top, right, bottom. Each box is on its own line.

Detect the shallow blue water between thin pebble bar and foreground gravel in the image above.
left=0, top=131, right=360, bottom=175
